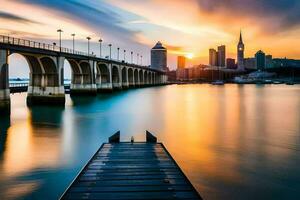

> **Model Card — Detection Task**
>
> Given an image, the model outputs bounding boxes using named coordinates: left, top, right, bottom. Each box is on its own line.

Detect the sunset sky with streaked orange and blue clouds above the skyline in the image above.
left=0, top=0, right=300, bottom=76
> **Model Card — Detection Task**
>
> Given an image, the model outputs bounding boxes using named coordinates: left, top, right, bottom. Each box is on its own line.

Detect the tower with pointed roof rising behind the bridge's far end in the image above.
left=151, top=42, right=167, bottom=70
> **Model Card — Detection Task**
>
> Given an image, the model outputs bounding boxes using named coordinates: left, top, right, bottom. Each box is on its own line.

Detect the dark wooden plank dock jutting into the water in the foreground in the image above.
left=61, top=132, right=201, bottom=200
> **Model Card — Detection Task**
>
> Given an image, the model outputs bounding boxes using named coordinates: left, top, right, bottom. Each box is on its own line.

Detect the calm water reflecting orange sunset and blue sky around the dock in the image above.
left=0, top=85, right=300, bottom=199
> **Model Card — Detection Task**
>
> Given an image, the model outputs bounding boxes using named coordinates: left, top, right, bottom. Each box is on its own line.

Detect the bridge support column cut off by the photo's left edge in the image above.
left=0, top=50, right=10, bottom=115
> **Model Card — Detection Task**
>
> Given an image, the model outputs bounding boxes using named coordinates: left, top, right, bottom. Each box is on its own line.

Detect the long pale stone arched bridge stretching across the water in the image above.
left=0, top=36, right=167, bottom=113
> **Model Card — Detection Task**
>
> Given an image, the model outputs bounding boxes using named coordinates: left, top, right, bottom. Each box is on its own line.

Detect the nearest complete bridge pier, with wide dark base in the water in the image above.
left=27, top=57, right=65, bottom=106
